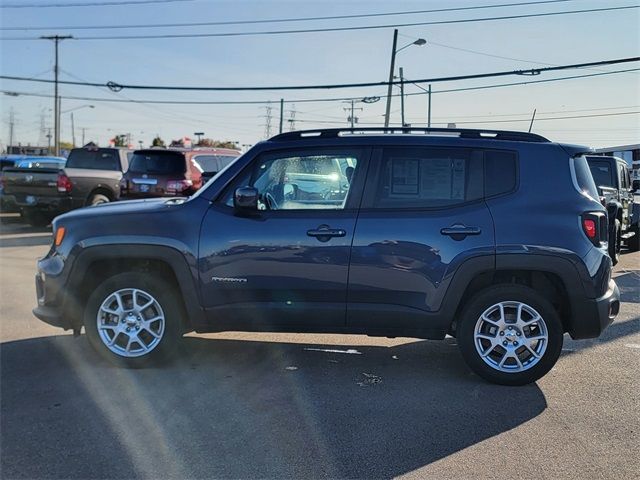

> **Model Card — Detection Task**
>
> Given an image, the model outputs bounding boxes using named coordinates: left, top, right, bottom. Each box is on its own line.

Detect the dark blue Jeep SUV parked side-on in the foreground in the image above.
left=34, top=129, right=620, bottom=385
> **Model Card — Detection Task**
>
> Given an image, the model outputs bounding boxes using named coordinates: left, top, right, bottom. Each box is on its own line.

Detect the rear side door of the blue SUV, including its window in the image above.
left=347, top=147, right=495, bottom=330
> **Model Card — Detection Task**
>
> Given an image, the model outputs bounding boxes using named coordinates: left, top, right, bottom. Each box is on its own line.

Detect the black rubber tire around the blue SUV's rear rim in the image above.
left=457, top=284, right=563, bottom=386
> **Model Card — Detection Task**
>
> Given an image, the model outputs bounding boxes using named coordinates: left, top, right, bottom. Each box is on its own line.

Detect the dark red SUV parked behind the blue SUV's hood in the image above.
left=120, top=148, right=240, bottom=199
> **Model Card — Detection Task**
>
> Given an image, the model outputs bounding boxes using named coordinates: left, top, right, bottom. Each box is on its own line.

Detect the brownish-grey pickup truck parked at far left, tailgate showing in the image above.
left=3, top=147, right=132, bottom=225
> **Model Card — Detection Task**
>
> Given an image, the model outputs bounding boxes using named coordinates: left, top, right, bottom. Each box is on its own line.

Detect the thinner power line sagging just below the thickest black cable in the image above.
left=0, top=68, right=640, bottom=105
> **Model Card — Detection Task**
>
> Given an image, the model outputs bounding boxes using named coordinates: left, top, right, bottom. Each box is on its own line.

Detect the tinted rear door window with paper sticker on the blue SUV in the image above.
left=374, top=148, right=482, bottom=208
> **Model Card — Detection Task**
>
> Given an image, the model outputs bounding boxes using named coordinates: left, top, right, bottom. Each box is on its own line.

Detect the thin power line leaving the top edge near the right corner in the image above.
left=0, top=0, right=578, bottom=30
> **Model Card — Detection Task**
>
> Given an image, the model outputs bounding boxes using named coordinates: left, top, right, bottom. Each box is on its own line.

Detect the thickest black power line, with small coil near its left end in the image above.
left=0, top=57, right=640, bottom=92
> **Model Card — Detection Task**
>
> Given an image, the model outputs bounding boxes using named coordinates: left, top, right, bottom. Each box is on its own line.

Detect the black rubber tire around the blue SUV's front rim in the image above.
left=84, top=272, right=184, bottom=368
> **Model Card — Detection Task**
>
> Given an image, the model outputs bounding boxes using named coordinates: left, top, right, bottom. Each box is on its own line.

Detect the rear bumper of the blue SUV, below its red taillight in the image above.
left=569, top=279, right=620, bottom=340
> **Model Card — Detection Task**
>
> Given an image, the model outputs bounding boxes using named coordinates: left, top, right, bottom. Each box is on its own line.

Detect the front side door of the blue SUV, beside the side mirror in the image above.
left=198, top=149, right=370, bottom=330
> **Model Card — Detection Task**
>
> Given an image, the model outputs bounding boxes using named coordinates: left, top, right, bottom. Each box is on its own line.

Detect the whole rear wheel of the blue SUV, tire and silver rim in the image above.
left=457, top=285, right=563, bottom=385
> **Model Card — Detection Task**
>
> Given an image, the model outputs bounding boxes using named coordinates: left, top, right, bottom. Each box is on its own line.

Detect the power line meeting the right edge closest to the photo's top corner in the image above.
left=0, top=5, right=640, bottom=41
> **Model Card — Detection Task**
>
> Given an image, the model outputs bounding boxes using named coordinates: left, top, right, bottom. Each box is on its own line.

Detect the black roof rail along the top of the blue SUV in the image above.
left=269, top=127, right=550, bottom=143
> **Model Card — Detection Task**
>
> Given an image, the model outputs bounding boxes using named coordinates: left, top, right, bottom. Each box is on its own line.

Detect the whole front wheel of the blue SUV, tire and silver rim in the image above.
left=84, top=272, right=183, bottom=367
